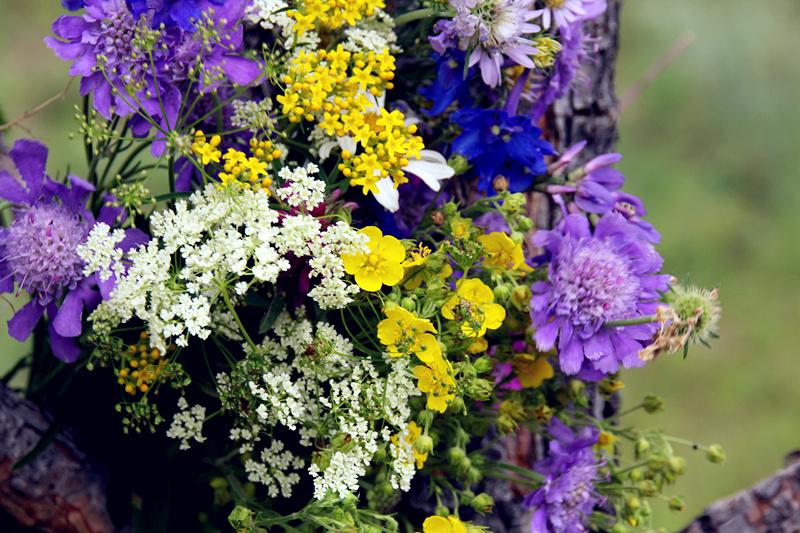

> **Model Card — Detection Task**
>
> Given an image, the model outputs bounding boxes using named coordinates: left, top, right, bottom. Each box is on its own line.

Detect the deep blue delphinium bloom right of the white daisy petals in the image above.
left=451, top=109, right=555, bottom=192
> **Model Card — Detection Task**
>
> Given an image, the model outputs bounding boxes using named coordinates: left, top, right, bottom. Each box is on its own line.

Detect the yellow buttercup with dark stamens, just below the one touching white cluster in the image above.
left=378, top=306, right=442, bottom=363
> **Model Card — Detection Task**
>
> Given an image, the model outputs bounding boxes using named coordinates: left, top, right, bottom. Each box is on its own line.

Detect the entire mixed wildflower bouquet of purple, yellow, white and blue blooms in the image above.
left=0, top=0, right=724, bottom=533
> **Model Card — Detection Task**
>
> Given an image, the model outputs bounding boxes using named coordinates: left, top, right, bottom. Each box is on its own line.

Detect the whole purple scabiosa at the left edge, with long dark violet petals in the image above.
left=0, top=140, right=100, bottom=362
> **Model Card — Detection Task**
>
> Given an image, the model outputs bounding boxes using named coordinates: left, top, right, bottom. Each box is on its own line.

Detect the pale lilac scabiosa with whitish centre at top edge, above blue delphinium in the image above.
left=431, top=0, right=541, bottom=87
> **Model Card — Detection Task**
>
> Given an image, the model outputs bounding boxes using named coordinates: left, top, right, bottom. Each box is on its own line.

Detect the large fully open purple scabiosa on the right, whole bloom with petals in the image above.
left=531, top=212, right=669, bottom=374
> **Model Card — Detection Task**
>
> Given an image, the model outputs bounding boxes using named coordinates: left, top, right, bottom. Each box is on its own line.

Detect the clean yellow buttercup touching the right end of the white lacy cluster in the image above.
left=342, top=226, right=406, bottom=292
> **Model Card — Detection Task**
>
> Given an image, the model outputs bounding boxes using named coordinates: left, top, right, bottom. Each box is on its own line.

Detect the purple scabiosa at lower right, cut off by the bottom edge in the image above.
left=524, top=418, right=603, bottom=533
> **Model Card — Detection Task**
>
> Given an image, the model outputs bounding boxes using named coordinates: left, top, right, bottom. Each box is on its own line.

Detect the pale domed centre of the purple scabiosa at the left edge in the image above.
left=5, top=203, right=88, bottom=304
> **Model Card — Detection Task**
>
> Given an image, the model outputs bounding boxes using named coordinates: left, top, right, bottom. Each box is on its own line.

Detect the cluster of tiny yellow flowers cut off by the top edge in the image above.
left=286, top=0, right=386, bottom=35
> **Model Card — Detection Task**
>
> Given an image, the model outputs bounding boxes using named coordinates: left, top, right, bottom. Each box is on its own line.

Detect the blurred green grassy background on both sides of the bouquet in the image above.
left=0, top=0, right=800, bottom=530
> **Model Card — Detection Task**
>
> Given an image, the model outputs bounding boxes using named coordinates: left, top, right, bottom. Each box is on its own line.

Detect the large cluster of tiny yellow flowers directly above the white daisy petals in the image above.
left=278, top=45, right=425, bottom=194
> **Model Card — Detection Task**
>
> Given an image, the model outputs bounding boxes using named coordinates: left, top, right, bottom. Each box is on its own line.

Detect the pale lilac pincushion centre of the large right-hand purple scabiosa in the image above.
left=550, top=236, right=639, bottom=328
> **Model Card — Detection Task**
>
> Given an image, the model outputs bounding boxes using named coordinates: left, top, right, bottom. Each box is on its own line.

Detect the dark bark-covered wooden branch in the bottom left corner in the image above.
left=0, top=384, right=114, bottom=533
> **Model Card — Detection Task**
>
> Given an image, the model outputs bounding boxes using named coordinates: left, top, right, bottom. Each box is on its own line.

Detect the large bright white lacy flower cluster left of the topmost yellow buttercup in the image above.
left=81, top=185, right=366, bottom=351
